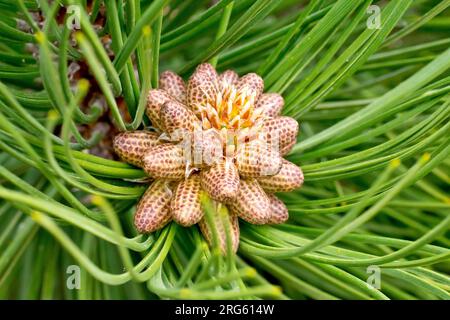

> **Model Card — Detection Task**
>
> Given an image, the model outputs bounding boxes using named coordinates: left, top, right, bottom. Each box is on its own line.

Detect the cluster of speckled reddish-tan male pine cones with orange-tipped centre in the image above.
left=113, top=63, right=303, bottom=253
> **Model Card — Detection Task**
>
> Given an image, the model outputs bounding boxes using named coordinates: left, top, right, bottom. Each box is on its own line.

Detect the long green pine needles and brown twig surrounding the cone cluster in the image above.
left=0, top=0, right=450, bottom=299
